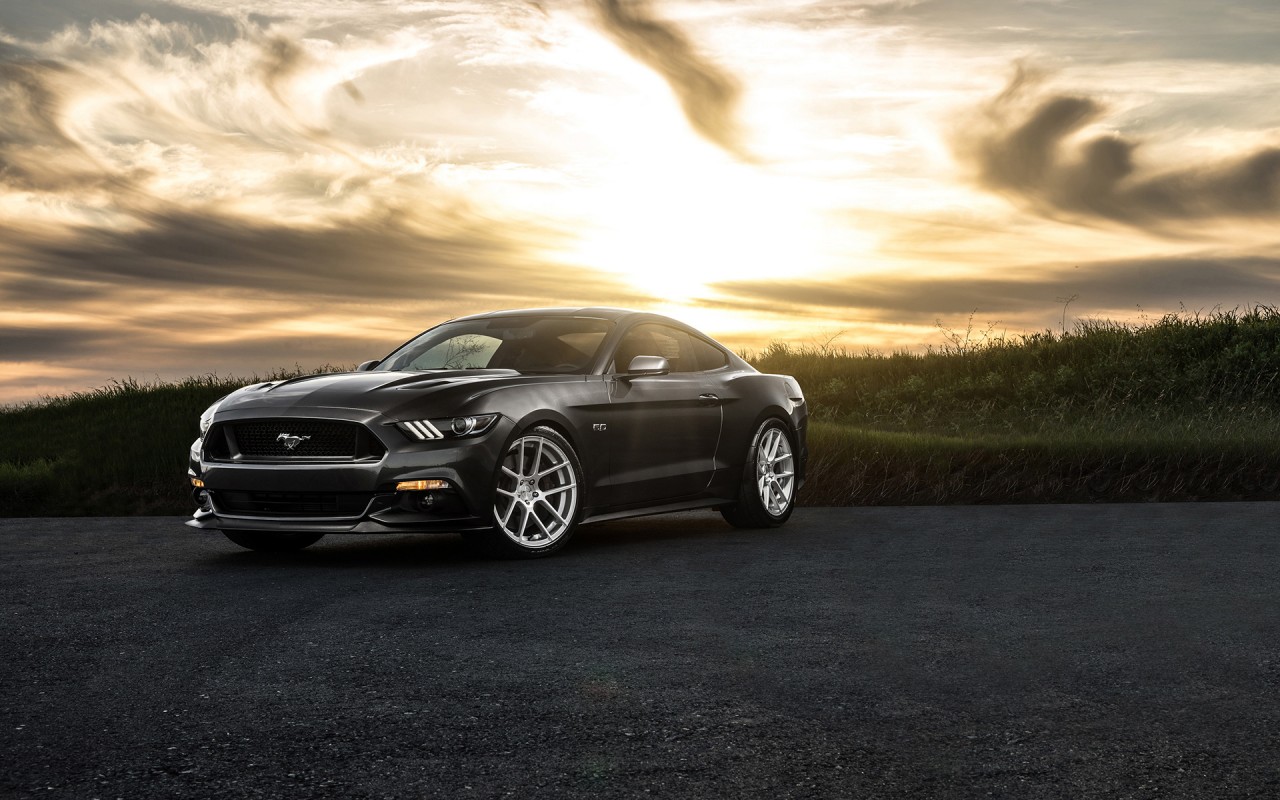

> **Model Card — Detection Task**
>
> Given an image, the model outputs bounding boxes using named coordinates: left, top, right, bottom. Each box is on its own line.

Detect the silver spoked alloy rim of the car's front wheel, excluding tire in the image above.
left=493, top=434, right=577, bottom=549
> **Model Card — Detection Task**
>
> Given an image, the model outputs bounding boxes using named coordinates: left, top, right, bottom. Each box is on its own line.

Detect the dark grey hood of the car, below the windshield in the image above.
left=218, top=370, right=555, bottom=413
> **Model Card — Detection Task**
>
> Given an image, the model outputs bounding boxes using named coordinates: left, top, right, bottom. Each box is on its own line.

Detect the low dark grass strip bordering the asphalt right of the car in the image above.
left=804, top=422, right=1280, bottom=506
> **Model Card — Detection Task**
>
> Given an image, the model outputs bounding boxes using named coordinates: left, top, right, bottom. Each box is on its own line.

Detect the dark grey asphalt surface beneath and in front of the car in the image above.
left=0, top=503, right=1280, bottom=799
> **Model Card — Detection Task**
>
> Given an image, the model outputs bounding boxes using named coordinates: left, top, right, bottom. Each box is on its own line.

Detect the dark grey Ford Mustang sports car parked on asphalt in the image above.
left=187, top=308, right=808, bottom=558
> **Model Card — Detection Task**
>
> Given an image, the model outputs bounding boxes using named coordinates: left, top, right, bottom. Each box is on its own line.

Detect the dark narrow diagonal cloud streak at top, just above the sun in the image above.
left=594, top=0, right=753, bottom=161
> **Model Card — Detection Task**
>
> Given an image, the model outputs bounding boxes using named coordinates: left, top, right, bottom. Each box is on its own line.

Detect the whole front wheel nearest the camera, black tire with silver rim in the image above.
left=467, top=426, right=582, bottom=558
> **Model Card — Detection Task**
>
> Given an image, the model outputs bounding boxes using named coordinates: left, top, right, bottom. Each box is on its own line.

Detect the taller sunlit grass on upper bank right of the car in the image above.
left=753, top=306, right=1280, bottom=435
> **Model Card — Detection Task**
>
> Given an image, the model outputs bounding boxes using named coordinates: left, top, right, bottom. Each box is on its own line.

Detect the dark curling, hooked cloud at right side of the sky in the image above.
left=956, top=64, right=1280, bottom=227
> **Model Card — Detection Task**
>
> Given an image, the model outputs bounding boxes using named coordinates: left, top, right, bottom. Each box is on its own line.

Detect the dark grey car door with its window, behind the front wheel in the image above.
left=598, top=323, right=721, bottom=506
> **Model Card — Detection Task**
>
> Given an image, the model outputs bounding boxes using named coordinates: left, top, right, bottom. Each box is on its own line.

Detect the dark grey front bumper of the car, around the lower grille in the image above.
left=187, top=408, right=513, bottom=534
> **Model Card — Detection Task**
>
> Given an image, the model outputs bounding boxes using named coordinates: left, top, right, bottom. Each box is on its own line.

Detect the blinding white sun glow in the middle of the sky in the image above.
left=514, top=35, right=828, bottom=302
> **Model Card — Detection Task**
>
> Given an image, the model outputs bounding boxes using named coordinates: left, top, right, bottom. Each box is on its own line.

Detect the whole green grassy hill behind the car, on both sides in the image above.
left=0, top=307, right=1280, bottom=516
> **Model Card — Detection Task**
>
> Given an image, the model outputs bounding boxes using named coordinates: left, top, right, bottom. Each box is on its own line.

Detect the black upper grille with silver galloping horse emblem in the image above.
left=205, top=417, right=387, bottom=461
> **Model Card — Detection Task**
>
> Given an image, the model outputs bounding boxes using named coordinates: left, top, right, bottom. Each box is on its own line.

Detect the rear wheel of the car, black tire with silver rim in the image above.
left=719, top=419, right=796, bottom=527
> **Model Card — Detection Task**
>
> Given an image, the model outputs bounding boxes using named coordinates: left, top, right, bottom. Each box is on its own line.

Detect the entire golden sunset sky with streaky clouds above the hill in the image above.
left=0, top=0, right=1280, bottom=403
